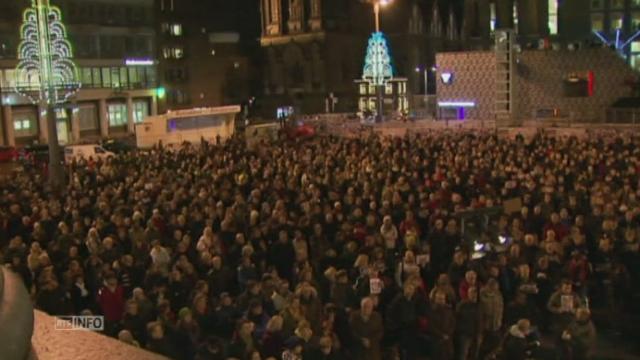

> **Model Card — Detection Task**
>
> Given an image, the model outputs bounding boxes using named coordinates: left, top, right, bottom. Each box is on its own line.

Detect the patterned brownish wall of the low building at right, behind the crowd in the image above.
left=436, top=49, right=636, bottom=121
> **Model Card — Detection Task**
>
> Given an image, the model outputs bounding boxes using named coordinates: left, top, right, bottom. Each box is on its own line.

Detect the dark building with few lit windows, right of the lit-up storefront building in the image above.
left=155, top=0, right=259, bottom=112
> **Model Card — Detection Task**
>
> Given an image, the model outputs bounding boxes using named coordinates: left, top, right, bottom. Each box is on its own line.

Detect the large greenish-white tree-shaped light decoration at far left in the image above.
left=15, top=0, right=81, bottom=104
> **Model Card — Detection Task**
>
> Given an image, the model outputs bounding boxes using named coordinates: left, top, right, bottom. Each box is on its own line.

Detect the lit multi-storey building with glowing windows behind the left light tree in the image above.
left=0, top=0, right=157, bottom=145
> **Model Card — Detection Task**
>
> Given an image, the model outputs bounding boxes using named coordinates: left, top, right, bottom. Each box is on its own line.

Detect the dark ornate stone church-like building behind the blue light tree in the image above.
left=260, top=0, right=438, bottom=114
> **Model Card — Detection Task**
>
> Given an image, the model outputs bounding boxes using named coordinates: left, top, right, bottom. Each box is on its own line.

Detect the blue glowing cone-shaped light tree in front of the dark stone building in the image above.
left=362, top=32, right=393, bottom=86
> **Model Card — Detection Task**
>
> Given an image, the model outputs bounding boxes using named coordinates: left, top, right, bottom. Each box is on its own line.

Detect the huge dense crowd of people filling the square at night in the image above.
left=0, top=131, right=640, bottom=360
